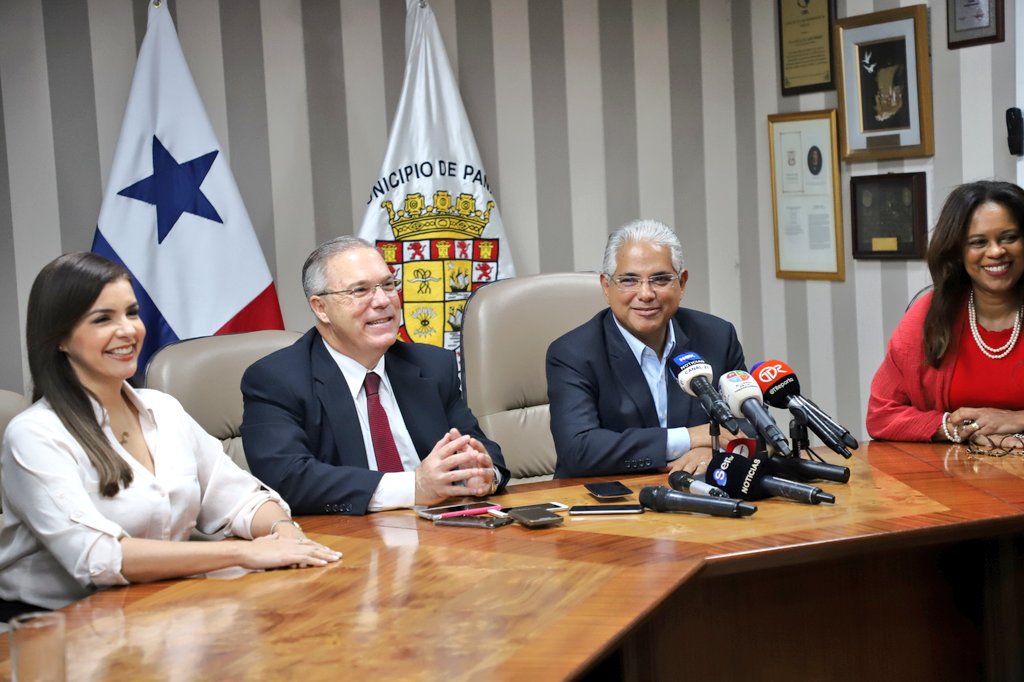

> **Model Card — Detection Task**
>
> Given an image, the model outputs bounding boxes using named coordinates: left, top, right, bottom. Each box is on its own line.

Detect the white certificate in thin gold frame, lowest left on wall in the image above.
left=768, top=109, right=845, bottom=282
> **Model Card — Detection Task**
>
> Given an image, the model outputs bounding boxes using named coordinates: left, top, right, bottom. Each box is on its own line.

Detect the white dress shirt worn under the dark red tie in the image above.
left=324, top=341, right=420, bottom=512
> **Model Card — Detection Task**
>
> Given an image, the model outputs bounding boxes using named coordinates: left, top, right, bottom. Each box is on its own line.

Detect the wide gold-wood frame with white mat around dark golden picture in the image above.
left=836, top=5, right=935, bottom=161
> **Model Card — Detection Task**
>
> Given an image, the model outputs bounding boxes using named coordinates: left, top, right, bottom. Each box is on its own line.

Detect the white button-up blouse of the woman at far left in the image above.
left=0, top=384, right=289, bottom=608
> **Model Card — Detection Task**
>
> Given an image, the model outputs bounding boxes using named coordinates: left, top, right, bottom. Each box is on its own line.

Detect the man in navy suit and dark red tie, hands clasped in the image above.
left=242, top=237, right=509, bottom=514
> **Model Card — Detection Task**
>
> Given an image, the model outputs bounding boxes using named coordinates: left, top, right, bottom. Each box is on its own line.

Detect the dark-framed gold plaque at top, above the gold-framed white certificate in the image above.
left=776, top=0, right=836, bottom=95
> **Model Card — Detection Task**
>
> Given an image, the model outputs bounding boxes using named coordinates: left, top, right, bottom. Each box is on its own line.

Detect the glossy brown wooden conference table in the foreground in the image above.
left=0, top=442, right=1024, bottom=681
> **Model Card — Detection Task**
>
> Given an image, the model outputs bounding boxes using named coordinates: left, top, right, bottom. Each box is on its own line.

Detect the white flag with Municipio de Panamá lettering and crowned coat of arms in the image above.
left=359, top=0, right=515, bottom=350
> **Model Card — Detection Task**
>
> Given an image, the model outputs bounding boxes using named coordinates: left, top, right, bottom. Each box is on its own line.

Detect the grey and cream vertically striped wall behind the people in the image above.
left=0, top=0, right=1018, bottom=440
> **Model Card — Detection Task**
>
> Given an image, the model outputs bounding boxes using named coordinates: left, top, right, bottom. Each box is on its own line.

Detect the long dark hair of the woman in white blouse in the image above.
left=26, top=253, right=132, bottom=498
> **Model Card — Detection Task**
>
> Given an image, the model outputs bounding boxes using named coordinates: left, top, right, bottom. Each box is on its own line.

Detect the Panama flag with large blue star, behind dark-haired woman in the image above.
left=92, top=0, right=284, bottom=373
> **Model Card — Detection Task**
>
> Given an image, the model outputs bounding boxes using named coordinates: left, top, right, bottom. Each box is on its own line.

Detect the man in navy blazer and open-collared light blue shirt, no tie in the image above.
left=547, top=220, right=745, bottom=478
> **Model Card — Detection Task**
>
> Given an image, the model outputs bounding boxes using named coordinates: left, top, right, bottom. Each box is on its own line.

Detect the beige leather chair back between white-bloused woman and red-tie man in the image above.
left=145, top=331, right=301, bottom=471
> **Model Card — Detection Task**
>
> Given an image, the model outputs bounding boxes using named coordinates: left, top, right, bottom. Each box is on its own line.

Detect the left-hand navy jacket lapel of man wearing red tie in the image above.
left=310, top=334, right=368, bottom=467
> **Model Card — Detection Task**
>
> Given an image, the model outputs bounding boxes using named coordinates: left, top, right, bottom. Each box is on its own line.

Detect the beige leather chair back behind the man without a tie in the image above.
left=462, top=272, right=607, bottom=479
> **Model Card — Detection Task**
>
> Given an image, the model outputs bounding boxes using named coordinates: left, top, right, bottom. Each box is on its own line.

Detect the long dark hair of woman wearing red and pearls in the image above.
left=925, top=180, right=1024, bottom=368
